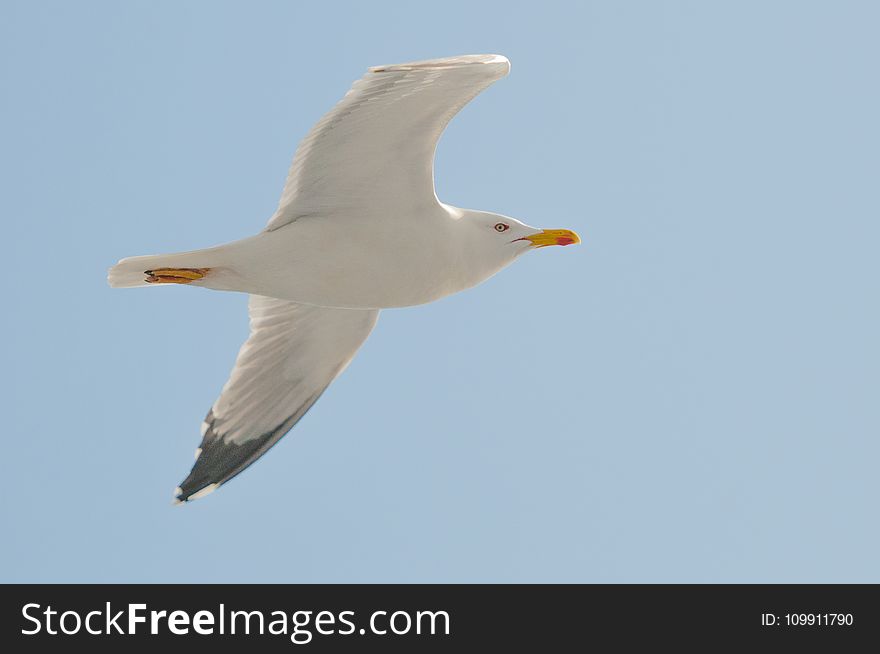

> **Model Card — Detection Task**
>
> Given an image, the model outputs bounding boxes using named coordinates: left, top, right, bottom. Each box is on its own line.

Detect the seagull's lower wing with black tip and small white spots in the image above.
left=175, top=295, right=379, bottom=501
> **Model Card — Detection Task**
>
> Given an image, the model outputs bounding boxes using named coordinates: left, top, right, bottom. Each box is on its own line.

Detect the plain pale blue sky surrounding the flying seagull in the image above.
left=0, top=0, right=880, bottom=582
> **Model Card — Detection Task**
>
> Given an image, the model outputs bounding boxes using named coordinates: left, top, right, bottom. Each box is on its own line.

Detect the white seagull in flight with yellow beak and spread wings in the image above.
left=108, top=54, right=580, bottom=503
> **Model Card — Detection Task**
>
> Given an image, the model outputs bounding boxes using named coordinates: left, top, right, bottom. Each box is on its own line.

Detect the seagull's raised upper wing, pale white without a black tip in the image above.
left=266, top=55, right=510, bottom=231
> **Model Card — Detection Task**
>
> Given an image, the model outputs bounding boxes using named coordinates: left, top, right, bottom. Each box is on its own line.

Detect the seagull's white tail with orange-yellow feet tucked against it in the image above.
left=107, top=248, right=224, bottom=288
